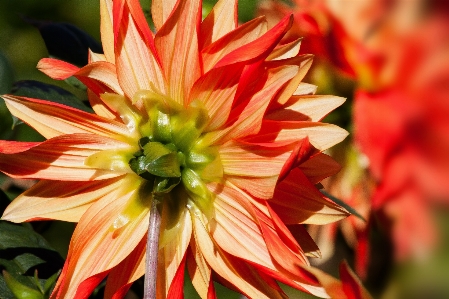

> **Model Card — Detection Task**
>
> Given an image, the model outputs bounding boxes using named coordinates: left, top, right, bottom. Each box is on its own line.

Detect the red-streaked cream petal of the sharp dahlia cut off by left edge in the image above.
left=0, top=134, right=132, bottom=181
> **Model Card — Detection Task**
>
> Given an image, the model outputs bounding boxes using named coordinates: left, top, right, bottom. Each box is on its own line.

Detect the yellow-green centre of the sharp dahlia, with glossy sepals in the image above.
left=129, top=91, right=223, bottom=206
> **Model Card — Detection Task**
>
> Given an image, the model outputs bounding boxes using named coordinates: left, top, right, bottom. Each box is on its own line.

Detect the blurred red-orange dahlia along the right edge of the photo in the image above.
left=354, top=15, right=449, bottom=260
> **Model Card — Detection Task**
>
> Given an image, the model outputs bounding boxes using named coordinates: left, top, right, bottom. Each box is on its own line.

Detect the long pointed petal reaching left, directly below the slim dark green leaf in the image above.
left=2, top=95, right=129, bottom=142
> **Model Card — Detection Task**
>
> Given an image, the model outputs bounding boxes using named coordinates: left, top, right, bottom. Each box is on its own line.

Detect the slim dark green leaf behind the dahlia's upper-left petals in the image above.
left=11, top=80, right=93, bottom=112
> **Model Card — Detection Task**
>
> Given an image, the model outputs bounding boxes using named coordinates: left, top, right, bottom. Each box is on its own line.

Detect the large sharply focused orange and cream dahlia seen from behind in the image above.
left=0, top=0, right=348, bottom=298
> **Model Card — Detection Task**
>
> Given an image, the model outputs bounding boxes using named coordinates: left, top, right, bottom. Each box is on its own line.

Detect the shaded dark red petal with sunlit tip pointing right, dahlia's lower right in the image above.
left=269, top=168, right=349, bottom=224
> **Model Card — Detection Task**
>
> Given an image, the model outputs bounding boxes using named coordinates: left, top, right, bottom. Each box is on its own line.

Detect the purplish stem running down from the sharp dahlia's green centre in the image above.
left=143, top=196, right=161, bottom=299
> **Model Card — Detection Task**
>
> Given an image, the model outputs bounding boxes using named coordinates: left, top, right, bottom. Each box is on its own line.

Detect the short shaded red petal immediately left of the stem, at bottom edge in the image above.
left=104, top=236, right=147, bottom=299
